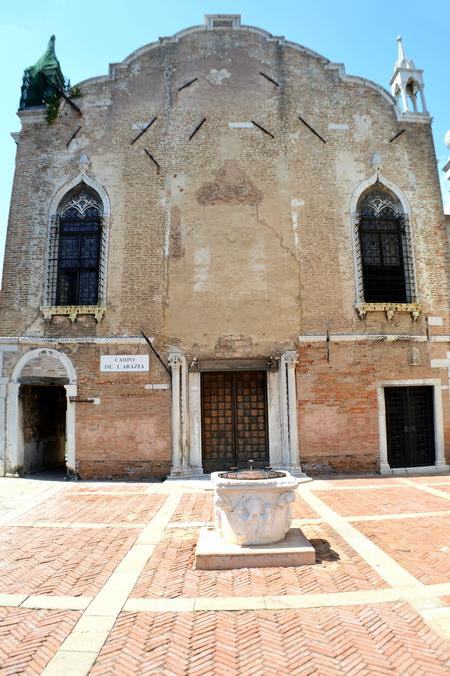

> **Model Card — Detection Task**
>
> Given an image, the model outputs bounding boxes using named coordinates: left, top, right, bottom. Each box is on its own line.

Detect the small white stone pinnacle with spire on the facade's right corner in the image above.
left=390, top=35, right=429, bottom=117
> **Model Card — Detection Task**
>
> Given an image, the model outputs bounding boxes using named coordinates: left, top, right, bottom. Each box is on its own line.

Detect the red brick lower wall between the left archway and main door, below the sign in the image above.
left=72, top=345, right=171, bottom=479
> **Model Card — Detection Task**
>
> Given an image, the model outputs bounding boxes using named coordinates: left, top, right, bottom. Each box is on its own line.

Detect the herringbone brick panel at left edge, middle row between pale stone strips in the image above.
left=0, top=527, right=139, bottom=596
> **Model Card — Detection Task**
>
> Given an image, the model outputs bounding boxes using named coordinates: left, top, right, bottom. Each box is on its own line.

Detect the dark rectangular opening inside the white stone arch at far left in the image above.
left=19, top=385, right=66, bottom=474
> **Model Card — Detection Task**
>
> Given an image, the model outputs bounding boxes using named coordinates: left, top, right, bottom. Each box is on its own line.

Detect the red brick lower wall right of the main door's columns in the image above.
left=297, top=340, right=450, bottom=473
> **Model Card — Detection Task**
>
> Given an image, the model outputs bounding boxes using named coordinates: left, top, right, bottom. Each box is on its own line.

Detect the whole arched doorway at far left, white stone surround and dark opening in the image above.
left=6, top=348, right=77, bottom=476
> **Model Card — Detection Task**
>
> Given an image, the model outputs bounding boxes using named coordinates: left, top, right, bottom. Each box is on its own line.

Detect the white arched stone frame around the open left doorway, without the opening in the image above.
left=5, top=347, right=77, bottom=476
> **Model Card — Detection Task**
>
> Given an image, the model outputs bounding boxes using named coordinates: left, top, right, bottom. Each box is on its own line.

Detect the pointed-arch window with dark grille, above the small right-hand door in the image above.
left=357, top=183, right=415, bottom=303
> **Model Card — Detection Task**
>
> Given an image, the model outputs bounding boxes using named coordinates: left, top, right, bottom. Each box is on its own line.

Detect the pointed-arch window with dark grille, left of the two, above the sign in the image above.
left=48, top=183, right=103, bottom=306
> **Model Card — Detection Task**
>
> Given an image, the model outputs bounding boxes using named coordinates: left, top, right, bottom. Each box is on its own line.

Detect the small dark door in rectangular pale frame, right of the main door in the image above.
left=384, top=387, right=435, bottom=467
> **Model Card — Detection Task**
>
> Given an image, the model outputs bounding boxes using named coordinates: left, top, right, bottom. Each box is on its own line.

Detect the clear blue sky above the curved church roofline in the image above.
left=0, top=0, right=450, bottom=276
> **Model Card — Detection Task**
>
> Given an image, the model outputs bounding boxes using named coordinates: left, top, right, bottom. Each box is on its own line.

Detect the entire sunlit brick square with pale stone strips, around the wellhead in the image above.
left=0, top=476, right=450, bottom=676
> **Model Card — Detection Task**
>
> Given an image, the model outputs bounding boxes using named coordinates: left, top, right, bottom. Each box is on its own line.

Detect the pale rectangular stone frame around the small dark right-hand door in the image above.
left=377, top=378, right=449, bottom=475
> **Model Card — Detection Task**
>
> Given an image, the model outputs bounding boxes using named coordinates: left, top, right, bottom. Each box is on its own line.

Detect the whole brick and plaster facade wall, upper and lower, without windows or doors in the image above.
left=0, top=19, right=450, bottom=476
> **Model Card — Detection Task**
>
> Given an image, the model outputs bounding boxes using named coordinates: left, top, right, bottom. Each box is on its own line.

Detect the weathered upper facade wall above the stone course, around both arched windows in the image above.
left=2, top=25, right=447, bottom=354
